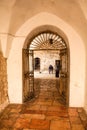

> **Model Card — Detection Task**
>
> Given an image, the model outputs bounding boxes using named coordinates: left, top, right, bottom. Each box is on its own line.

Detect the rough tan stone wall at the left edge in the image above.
left=0, top=52, right=8, bottom=111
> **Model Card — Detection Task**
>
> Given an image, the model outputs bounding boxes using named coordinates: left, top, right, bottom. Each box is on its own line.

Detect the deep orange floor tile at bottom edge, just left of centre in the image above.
left=30, top=119, right=50, bottom=130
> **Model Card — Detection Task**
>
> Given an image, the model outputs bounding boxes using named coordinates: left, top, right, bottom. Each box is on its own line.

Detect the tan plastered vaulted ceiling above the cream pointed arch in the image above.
left=0, top=0, right=87, bottom=35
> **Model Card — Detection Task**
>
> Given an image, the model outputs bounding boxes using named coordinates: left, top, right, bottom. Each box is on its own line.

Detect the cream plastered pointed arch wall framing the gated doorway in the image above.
left=7, top=12, right=85, bottom=107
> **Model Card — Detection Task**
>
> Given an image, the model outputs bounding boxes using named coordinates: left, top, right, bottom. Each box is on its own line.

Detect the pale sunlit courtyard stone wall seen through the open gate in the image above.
left=34, top=50, right=60, bottom=72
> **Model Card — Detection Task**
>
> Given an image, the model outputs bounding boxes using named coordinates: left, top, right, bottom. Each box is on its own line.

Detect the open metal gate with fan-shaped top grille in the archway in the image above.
left=23, top=30, right=69, bottom=104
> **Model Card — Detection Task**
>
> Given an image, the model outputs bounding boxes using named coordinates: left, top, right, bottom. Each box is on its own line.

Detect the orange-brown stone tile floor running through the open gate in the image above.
left=0, top=79, right=87, bottom=130
